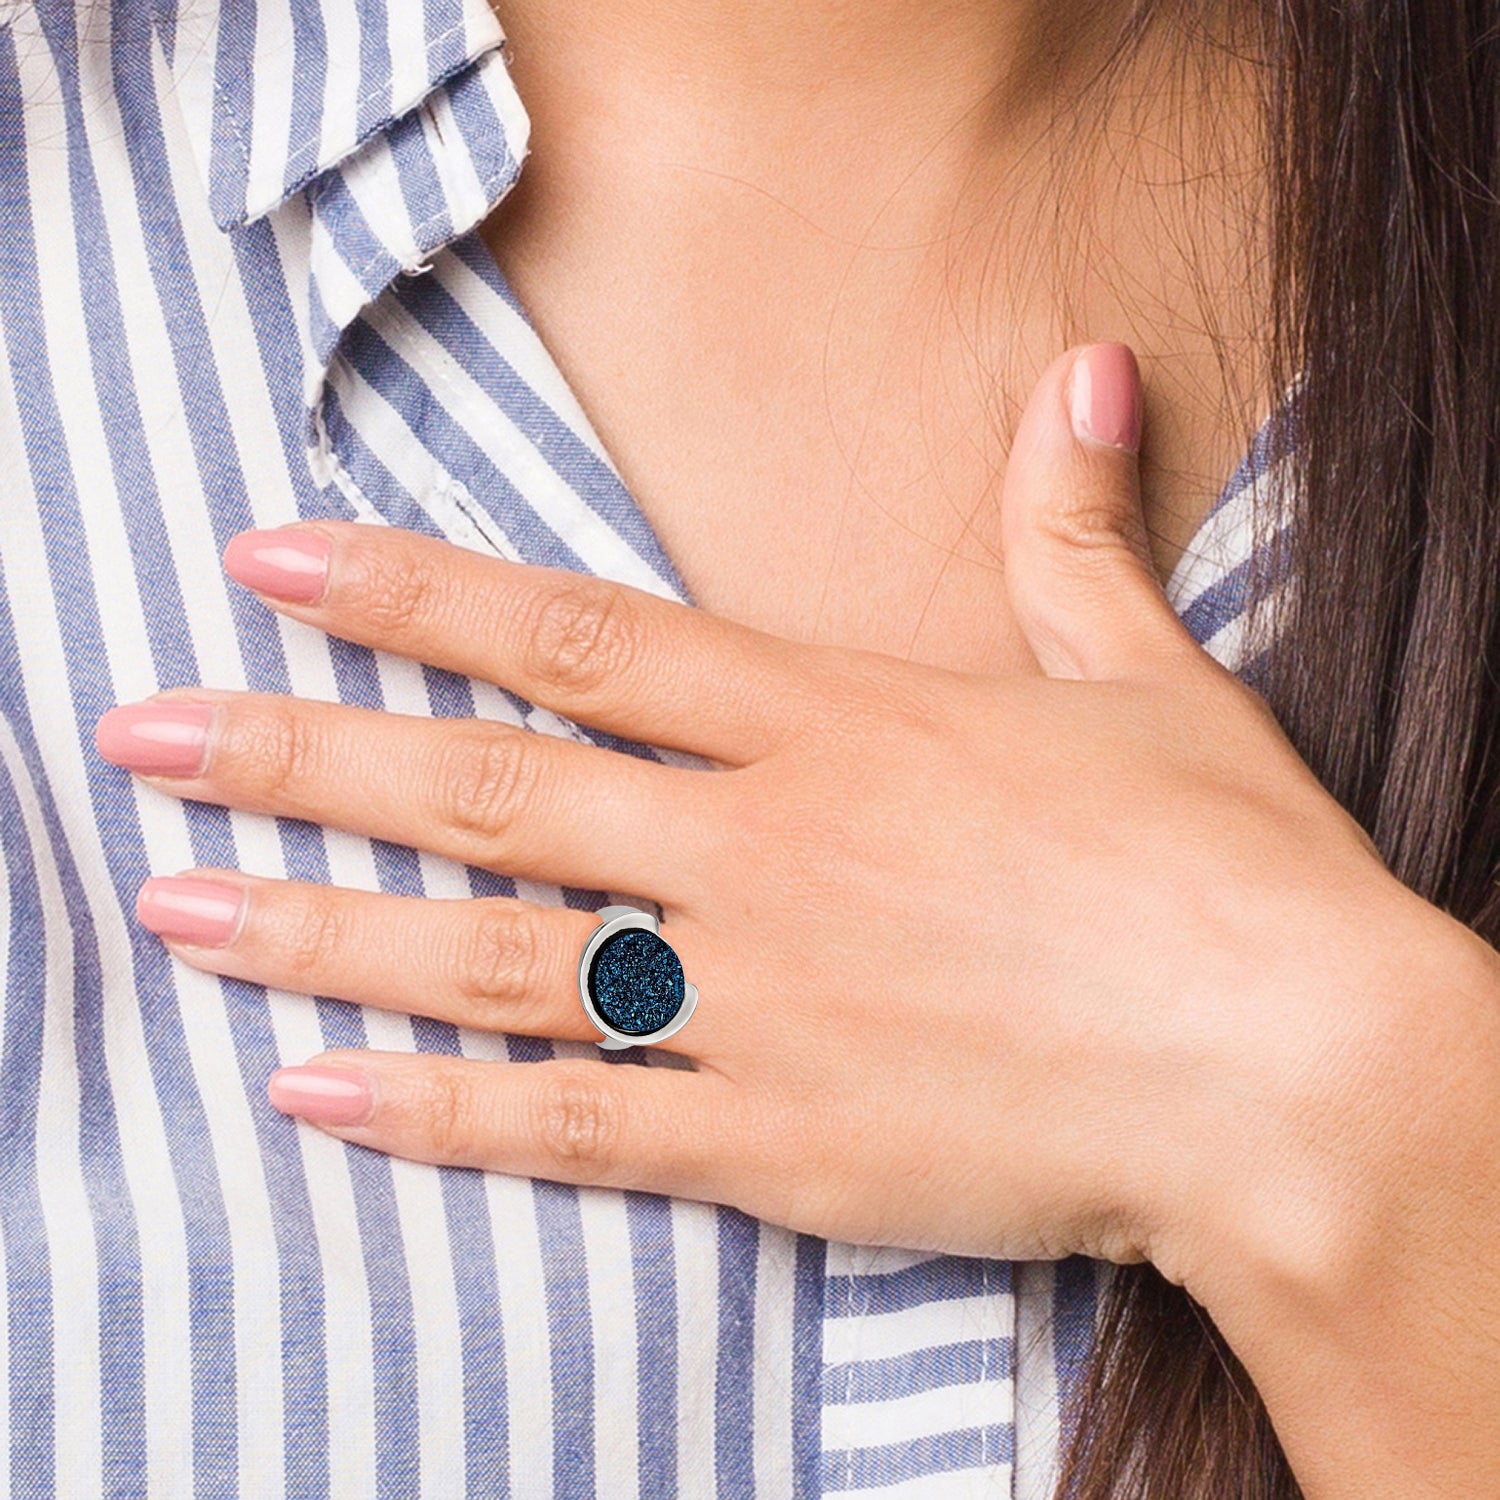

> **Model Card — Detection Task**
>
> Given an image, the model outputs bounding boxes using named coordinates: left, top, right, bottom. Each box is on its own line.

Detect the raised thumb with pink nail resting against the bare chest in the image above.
left=1001, top=344, right=1197, bottom=678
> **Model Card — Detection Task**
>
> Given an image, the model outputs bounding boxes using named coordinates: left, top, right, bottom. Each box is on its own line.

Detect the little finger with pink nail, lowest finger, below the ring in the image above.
left=267, top=1052, right=744, bottom=1202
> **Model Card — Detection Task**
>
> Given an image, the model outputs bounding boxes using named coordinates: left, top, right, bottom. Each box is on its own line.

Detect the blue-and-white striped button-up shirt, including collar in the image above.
left=0, top=0, right=1290, bottom=1500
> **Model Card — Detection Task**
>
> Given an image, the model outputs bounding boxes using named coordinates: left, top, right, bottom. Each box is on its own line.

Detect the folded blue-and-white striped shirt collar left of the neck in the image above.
left=156, top=0, right=530, bottom=468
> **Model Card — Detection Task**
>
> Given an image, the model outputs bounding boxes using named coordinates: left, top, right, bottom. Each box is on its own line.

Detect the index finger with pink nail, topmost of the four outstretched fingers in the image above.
left=224, top=522, right=858, bottom=765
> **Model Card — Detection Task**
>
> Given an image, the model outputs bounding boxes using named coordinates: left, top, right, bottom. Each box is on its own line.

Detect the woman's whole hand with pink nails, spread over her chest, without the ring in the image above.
left=90, top=345, right=1430, bottom=1302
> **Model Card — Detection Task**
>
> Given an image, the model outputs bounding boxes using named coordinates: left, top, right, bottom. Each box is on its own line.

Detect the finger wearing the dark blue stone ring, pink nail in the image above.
left=135, top=870, right=714, bottom=1052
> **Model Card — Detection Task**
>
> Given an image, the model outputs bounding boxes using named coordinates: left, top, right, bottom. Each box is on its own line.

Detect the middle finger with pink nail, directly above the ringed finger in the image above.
left=96, top=689, right=728, bottom=906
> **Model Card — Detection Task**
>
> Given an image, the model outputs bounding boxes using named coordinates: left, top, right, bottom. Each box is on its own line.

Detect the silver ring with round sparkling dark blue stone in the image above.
left=578, top=906, right=698, bottom=1052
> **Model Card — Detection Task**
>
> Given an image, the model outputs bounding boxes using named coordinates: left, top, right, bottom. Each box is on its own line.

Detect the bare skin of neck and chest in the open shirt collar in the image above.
left=485, top=0, right=1266, bottom=672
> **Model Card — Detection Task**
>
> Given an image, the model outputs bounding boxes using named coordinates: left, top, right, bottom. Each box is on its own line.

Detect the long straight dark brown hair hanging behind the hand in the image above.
left=1059, top=0, right=1500, bottom=1500
